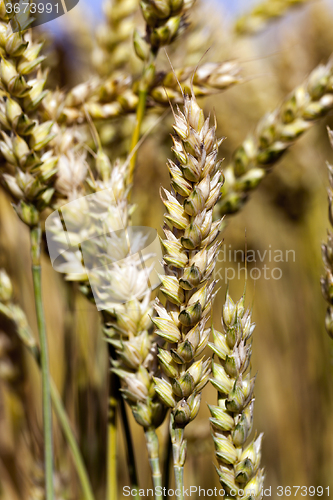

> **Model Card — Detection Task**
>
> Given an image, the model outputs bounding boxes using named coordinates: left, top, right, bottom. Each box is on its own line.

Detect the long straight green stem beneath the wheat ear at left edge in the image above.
left=30, top=224, right=54, bottom=500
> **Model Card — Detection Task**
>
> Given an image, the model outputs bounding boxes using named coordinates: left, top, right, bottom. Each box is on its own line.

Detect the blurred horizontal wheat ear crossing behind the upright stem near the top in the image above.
left=55, top=61, right=242, bottom=126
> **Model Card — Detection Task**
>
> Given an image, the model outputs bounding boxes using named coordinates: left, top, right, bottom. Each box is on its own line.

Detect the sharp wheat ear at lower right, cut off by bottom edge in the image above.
left=209, top=292, right=264, bottom=500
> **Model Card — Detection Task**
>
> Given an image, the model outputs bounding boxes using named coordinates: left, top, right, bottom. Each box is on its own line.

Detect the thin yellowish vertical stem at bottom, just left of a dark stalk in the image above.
left=107, top=372, right=119, bottom=500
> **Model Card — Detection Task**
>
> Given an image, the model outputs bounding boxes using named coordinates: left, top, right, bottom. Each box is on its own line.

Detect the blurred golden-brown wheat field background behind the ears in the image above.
left=0, top=0, right=333, bottom=500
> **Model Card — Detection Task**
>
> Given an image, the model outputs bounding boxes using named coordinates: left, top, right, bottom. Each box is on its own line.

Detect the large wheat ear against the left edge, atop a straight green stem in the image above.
left=0, top=20, right=58, bottom=227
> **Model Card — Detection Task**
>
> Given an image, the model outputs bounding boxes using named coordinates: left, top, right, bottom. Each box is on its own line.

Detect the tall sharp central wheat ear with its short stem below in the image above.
left=153, top=96, right=222, bottom=498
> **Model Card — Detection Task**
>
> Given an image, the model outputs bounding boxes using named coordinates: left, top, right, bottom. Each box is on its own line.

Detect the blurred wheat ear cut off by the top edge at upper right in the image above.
left=235, top=0, right=312, bottom=35
